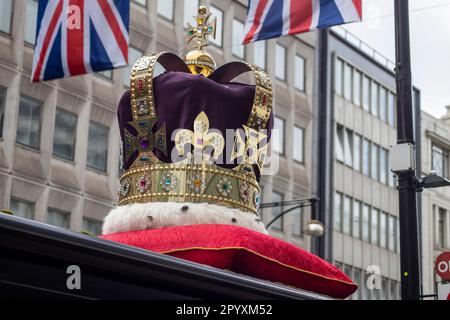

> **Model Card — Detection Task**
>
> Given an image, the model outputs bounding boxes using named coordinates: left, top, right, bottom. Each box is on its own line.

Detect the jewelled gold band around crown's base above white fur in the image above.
left=119, top=163, right=260, bottom=214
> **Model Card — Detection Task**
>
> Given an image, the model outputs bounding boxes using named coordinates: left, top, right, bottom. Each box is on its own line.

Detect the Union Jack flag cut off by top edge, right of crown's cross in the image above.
left=244, top=0, right=362, bottom=44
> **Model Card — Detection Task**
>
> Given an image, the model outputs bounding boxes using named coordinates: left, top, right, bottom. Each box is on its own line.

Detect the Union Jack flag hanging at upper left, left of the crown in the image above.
left=31, top=0, right=130, bottom=82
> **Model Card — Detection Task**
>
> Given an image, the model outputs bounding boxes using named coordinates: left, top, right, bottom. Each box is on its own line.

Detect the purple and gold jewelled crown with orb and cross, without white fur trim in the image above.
left=118, top=7, right=273, bottom=214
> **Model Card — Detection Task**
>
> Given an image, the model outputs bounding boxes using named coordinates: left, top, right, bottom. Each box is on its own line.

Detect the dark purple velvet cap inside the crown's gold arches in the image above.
left=117, top=71, right=273, bottom=179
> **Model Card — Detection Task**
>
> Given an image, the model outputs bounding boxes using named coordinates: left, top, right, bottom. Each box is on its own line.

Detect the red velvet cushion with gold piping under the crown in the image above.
left=102, top=224, right=357, bottom=298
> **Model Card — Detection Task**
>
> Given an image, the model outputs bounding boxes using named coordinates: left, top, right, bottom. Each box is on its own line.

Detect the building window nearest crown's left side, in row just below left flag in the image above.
left=87, top=121, right=109, bottom=171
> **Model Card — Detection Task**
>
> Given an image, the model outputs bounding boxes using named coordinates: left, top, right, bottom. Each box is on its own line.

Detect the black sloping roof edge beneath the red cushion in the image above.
left=0, top=213, right=328, bottom=300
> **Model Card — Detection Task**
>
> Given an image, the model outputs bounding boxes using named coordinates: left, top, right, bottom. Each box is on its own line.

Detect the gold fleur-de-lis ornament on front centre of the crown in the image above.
left=175, top=112, right=225, bottom=164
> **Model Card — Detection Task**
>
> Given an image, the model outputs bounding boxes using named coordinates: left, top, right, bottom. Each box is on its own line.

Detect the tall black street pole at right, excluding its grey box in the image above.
left=394, top=0, right=420, bottom=300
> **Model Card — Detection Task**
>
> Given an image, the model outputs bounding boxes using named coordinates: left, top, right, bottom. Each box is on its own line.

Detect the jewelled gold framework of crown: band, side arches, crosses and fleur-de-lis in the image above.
left=118, top=52, right=272, bottom=214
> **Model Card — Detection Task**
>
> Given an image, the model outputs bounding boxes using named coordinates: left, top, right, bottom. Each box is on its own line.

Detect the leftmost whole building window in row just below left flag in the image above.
left=16, top=96, right=41, bottom=149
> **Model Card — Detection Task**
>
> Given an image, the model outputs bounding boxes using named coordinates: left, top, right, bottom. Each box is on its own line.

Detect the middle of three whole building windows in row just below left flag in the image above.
left=53, top=108, right=77, bottom=160
